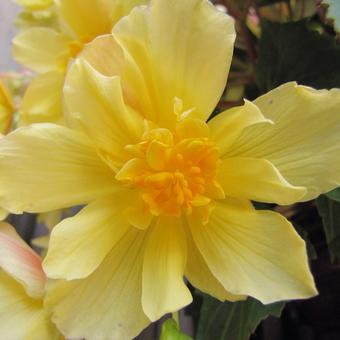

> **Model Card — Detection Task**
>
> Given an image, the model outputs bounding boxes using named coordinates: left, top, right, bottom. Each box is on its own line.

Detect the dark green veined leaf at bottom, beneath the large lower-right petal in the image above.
left=196, top=294, right=285, bottom=340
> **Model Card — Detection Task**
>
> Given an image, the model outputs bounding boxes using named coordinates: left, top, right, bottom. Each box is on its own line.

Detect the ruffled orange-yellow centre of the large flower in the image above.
left=116, top=122, right=224, bottom=217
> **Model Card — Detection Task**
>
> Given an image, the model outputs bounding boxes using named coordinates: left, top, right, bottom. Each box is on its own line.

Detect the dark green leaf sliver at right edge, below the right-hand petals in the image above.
left=316, top=195, right=340, bottom=262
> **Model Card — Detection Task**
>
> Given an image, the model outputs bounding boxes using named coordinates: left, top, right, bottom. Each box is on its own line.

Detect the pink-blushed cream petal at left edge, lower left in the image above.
left=0, top=222, right=46, bottom=297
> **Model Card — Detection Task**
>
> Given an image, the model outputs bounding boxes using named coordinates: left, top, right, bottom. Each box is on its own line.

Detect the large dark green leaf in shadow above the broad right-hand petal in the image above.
left=256, top=20, right=340, bottom=92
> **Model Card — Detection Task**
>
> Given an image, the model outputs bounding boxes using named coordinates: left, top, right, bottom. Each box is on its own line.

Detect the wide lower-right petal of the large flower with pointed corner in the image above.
left=190, top=199, right=317, bottom=304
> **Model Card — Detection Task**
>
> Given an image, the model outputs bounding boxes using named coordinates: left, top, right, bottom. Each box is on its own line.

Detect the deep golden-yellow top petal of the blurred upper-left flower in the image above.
left=58, top=0, right=148, bottom=40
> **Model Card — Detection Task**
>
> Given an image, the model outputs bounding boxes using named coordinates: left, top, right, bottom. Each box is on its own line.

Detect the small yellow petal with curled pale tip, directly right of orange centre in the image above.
left=218, top=157, right=306, bottom=205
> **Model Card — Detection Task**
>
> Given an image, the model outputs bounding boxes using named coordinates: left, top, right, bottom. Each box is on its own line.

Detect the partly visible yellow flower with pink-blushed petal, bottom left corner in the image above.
left=0, top=222, right=62, bottom=340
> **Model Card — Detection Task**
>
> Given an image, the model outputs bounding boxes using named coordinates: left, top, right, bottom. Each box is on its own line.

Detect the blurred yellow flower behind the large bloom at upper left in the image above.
left=13, top=0, right=148, bottom=125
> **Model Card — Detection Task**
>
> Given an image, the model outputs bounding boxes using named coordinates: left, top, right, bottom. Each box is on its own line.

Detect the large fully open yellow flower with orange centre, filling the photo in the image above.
left=0, top=0, right=340, bottom=339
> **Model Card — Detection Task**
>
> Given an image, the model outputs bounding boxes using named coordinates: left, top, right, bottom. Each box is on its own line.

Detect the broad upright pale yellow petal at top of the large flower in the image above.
left=82, top=0, right=235, bottom=126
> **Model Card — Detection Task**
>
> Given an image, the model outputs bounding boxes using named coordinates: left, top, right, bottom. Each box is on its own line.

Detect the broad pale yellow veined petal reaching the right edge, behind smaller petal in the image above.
left=228, top=83, right=340, bottom=201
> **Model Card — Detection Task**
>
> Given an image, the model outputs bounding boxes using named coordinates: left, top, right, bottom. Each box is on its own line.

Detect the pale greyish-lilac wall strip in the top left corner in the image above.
left=0, top=0, right=19, bottom=72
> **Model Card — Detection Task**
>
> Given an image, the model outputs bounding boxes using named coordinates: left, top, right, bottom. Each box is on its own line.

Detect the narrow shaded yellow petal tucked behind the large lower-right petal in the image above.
left=185, top=224, right=246, bottom=301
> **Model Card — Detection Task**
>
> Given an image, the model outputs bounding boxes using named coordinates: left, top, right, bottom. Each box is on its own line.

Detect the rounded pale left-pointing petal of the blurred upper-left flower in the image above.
left=13, top=27, right=70, bottom=73
